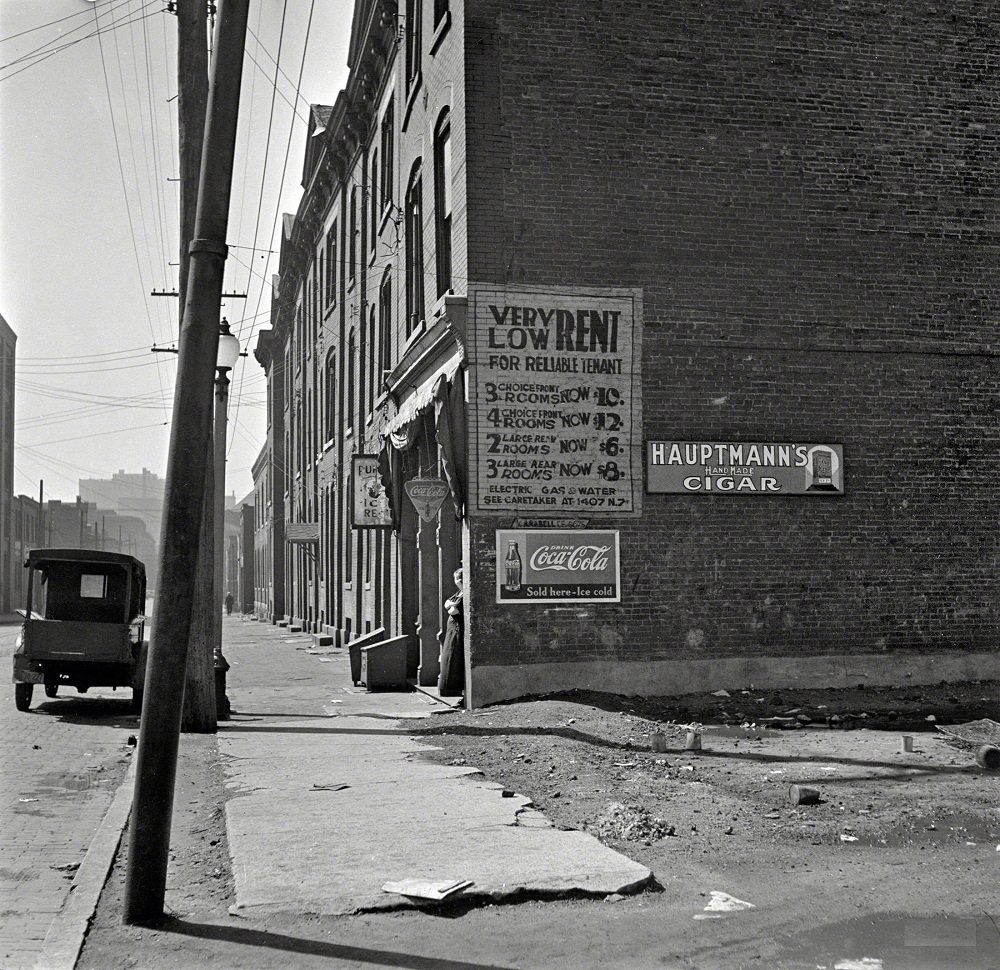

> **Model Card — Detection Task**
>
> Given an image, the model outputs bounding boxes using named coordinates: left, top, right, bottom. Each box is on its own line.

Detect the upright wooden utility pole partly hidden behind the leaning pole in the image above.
left=177, top=0, right=216, bottom=734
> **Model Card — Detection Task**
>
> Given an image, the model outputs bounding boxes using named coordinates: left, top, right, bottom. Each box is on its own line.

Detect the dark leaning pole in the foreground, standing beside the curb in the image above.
left=124, top=0, right=249, bottom=924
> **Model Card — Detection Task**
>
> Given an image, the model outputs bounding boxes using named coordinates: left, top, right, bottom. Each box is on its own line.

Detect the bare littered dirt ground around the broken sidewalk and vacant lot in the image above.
left=78, top=683, right=1000, bottom=970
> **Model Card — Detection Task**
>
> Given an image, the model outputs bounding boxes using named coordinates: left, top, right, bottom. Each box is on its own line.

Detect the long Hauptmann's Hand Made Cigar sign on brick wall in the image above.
left=646, top=441, right=844, bottom=496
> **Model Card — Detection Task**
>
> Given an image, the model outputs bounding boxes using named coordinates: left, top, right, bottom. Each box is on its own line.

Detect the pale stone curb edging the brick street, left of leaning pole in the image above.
left=35, top=754, right=138, bottom=970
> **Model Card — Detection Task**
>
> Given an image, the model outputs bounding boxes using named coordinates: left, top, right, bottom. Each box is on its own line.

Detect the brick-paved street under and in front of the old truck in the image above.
left=0, top=626, right=138, bottom=970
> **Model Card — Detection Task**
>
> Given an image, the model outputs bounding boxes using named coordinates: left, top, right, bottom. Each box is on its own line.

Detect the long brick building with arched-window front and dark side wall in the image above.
left=257, top=0, right=1000, bottom=704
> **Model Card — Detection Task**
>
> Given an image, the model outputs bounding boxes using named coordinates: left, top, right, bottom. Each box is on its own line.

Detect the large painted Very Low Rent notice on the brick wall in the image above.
left=469, top=283, right=642, bottom=517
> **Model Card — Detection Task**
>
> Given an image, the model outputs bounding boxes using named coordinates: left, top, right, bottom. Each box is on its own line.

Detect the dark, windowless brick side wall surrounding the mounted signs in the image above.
left=465, top=0, right=1000, bottom=665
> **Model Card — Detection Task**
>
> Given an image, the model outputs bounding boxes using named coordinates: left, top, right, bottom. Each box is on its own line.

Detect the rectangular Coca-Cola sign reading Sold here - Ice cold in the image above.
left=496, top=529, right=621, bottom=603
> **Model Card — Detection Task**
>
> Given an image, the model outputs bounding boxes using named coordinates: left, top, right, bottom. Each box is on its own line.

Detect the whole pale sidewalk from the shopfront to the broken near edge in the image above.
left=218, top=617, right=651, bottom=915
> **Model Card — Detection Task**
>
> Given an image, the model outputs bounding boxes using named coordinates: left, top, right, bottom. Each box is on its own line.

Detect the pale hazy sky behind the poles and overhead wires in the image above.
left=0, top=0, right=353, bottom=501
